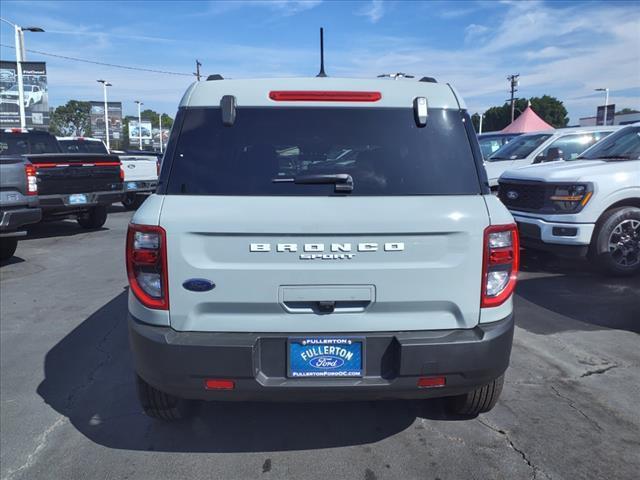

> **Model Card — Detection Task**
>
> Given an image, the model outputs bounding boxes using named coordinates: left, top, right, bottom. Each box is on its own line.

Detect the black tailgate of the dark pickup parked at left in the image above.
left=26, top=153, right=122, bottom=196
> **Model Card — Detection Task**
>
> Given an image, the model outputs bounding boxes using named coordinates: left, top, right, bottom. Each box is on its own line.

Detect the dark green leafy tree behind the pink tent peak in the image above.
left=474, top=95, right=569, bottom=132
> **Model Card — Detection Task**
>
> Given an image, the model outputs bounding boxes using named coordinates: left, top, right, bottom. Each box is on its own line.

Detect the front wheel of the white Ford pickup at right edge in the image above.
left=589, top=207, right=640, bottom=276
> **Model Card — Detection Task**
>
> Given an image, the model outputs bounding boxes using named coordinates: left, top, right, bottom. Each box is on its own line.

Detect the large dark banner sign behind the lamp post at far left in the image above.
left=0, top=61, right=50, bottom=130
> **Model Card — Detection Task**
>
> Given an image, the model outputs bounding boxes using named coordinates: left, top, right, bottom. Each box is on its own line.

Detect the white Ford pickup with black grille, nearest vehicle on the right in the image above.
left=499, top=124, right=640, bottom=275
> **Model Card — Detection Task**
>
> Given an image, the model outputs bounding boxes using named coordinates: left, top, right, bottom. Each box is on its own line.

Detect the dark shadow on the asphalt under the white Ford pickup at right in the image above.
left=515, top=251, right=640, bottom=334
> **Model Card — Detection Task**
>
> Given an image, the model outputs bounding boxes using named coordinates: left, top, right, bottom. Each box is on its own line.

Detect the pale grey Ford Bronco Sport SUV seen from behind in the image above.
left=126, top=76, right=519, bottom=420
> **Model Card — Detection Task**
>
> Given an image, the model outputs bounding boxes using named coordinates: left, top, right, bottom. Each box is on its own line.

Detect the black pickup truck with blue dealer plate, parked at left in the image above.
left=0, top=128, right=124, bottom=228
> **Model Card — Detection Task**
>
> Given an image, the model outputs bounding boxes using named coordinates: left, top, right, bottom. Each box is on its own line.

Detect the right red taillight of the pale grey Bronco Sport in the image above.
left=480, top=224, right=520, bottom=307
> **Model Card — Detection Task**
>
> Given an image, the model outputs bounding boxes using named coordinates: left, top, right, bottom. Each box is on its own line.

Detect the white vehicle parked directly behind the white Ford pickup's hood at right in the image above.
left=485, top=126, right=620, bottom=189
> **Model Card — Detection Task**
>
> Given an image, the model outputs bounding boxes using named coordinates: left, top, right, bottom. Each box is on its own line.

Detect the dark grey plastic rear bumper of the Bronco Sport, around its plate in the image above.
left=129, top=315, right=514, bottom=401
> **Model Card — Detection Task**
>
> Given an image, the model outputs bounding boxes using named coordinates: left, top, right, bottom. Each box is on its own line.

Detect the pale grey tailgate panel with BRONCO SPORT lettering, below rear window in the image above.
left=160, top=195, right=489, bottom=333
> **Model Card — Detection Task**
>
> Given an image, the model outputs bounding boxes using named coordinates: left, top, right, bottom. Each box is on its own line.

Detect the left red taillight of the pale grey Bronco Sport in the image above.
left=127, top=224, right=169, bottom=310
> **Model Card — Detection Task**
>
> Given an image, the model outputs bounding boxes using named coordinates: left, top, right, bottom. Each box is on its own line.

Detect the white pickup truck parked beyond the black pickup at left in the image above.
left=58, top=137, right=159, bottom=210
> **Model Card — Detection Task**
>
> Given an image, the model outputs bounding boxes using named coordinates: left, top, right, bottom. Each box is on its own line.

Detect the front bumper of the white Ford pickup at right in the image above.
left=511, top=212, right=595, bottom=256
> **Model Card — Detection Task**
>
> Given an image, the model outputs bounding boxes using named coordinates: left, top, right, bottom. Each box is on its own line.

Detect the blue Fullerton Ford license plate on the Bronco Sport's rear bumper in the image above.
left=286, top=336, right=366, bottom=379
